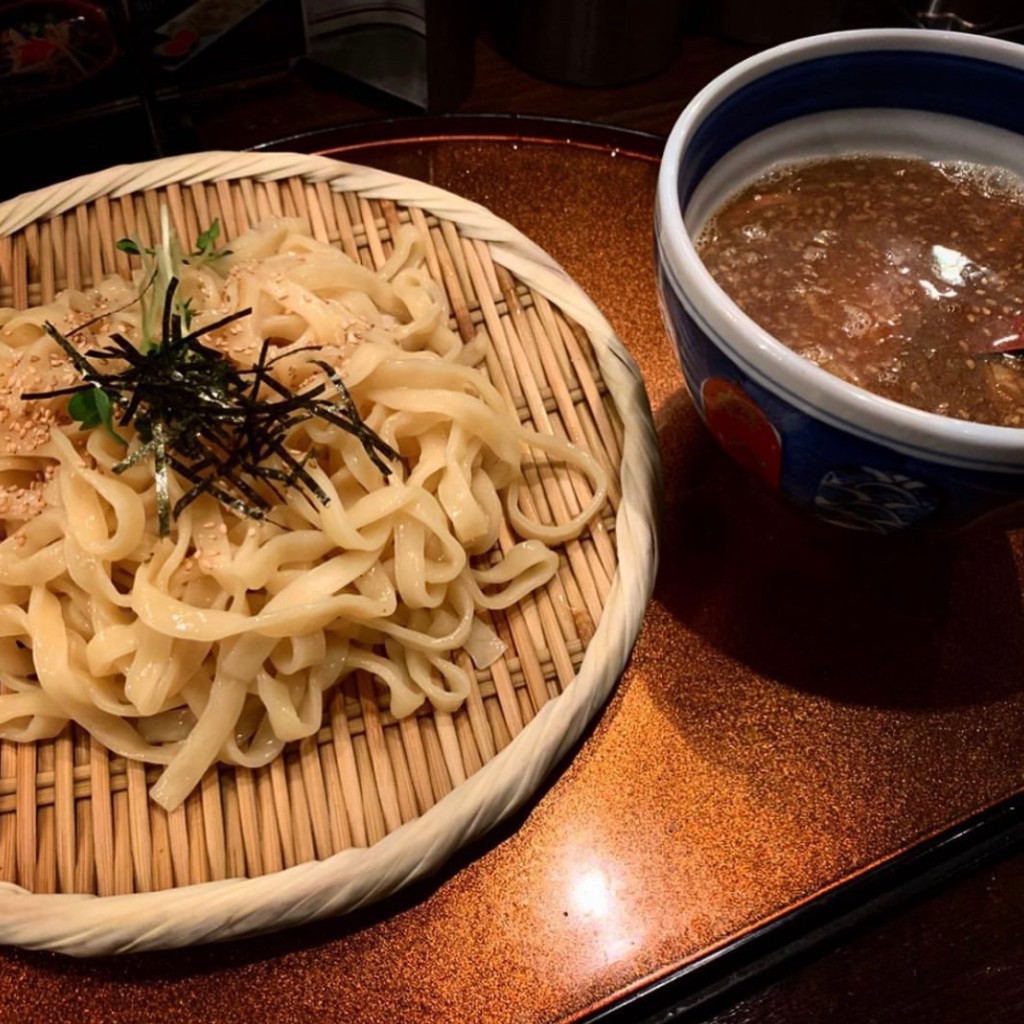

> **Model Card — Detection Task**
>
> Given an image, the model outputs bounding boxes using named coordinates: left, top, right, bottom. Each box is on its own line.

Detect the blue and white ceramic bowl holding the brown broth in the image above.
left=655, top=29, right=1024, bottom=534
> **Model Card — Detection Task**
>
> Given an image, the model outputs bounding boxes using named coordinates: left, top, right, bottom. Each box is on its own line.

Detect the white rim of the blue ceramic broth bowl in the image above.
left=655, top=29, right=1024, bottom=472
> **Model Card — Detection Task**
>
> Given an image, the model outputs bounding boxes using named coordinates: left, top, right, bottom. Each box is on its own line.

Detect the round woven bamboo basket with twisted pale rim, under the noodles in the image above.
left=0, top=153, right=658, bottom=955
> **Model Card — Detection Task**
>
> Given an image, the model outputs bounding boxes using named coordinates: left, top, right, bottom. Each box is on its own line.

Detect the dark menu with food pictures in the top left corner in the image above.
left=0, top=0, right=305, bottom=199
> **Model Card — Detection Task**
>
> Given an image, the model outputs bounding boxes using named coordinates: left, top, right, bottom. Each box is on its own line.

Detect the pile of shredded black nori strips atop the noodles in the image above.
left=22, top=278, right=399, bottom=537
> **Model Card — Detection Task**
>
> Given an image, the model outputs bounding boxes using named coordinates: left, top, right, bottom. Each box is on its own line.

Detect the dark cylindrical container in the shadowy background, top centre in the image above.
left=486, top=0, right=691, bottom=86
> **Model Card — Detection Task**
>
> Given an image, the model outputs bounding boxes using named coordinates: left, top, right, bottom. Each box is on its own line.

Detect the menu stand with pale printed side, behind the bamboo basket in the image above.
left=302, top=0, right=476, bottom=114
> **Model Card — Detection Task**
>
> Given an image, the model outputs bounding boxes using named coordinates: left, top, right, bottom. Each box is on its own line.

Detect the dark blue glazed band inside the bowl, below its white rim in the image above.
left=679, top=50, right=1024, bottom=210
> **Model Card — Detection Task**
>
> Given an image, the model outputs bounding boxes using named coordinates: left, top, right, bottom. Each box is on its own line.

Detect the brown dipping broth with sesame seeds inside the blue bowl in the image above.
left=697, top=156, right=1024, bottom=427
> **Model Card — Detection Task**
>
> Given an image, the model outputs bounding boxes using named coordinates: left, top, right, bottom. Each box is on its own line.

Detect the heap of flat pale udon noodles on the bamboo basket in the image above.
left=0, top=220, right=605, bottom=808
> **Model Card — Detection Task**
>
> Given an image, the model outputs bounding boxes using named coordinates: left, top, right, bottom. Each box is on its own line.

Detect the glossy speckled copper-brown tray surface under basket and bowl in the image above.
left=0, top=122, right=1024, bottom=1024
